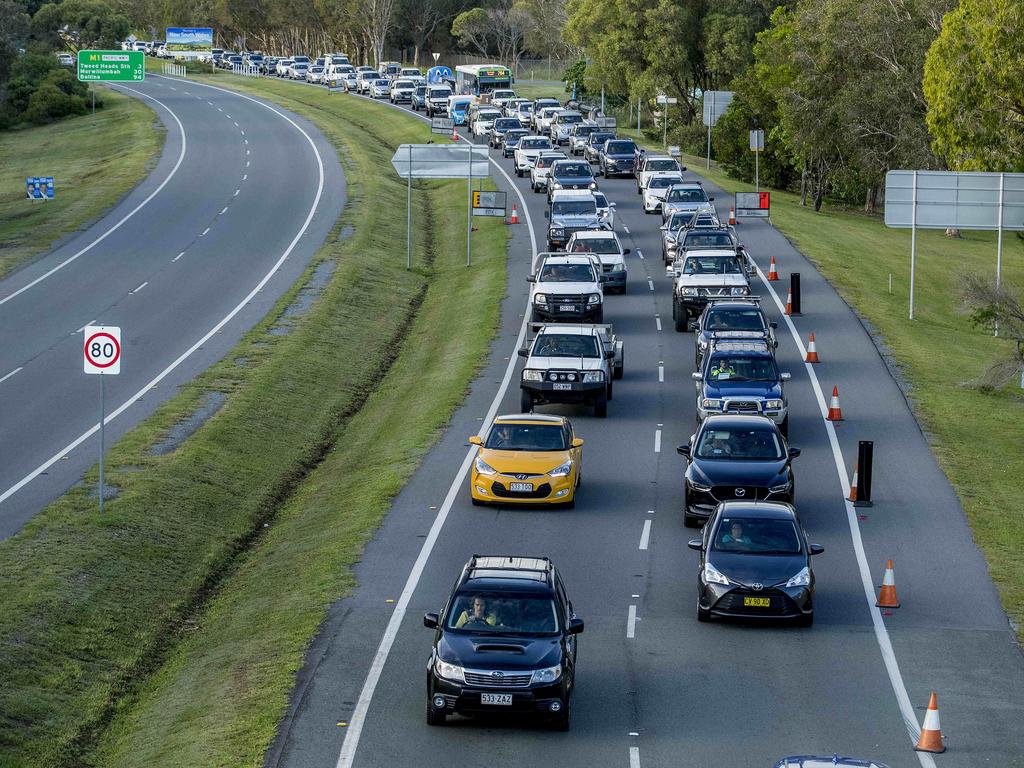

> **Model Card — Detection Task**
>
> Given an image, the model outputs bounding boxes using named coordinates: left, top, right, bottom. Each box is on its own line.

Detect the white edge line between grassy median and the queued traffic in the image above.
left=336, top=100, right=538, bottom=768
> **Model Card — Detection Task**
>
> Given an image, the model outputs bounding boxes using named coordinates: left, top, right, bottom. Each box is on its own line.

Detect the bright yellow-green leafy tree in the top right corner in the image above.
left=924, top=0, right=1024, bottom=171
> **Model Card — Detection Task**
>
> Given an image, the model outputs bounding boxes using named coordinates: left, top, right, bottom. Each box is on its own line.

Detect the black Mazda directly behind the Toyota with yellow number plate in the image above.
left=677, top=415, right=800, bottom=527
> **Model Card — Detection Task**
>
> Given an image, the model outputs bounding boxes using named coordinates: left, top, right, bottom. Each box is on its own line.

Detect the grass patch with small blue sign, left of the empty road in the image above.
left=0, top=89, right=165, bottom=278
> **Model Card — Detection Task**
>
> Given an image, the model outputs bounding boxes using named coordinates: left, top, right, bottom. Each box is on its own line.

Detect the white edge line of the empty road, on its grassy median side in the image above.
left=0, top=75, right=325, bottom=512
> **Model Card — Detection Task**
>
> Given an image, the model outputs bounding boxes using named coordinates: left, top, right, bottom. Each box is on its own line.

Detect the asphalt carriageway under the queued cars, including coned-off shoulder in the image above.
left=267, top=85, right=1024, bottom=768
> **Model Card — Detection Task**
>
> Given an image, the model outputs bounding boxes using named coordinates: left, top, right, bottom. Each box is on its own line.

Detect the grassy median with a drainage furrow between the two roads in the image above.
left=0, top=77, right=506, bottom=768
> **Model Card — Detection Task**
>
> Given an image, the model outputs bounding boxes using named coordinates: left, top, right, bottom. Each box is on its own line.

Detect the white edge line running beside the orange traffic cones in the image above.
left=758, top=250, right=935, bottom=768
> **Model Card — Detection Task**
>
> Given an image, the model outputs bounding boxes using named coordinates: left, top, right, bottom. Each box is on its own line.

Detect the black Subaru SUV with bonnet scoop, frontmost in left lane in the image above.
left=423, top=555, right=583, bottom=730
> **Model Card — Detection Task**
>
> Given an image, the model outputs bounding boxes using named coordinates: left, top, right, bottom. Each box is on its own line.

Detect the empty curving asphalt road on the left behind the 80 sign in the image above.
left=0, top=75, right=345, bottom=538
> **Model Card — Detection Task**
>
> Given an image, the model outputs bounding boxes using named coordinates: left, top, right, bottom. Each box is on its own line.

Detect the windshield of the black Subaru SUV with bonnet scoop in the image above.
left=447, top=592, right=558, bottom=635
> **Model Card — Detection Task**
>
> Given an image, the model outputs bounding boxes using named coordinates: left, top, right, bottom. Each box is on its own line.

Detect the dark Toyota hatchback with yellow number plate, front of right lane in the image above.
left=689, top=502, right=824, bottom=627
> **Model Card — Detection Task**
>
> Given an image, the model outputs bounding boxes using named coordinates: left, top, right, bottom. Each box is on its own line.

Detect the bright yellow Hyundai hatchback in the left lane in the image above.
left=469, top=414, right=583, bottom=507
